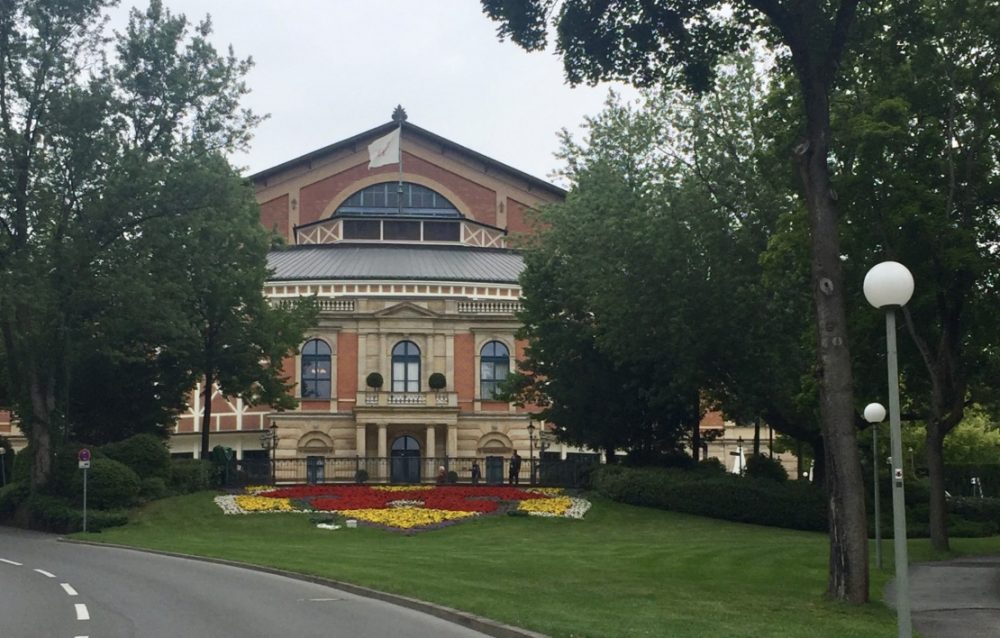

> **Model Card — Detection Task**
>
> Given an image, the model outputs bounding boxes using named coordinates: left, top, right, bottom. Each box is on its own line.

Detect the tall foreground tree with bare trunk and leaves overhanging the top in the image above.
left=483, top=0, right=868, bottom=603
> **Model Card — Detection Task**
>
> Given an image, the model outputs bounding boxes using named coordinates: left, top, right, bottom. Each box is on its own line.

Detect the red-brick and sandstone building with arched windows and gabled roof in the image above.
left=171, top=109, right=565, bottom=483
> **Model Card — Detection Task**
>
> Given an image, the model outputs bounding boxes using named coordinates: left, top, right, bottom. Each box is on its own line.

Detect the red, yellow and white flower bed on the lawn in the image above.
left=215, top=485, right=590, bottom=530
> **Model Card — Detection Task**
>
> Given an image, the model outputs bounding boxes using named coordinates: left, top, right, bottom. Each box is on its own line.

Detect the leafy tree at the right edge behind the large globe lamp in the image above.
left=835, top=0, right=1000, bottom=551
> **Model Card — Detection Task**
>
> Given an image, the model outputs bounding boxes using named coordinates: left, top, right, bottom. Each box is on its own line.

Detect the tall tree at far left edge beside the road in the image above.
left=0, top=0, right=257, bottom=489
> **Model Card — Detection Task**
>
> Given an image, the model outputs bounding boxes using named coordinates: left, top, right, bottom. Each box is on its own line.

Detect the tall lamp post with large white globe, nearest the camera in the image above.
left=864, top=261, right=913, bottom=638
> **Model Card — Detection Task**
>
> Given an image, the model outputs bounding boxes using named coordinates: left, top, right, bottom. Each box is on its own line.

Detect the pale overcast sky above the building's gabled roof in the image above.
left=113, top=0, right=634, bottom=186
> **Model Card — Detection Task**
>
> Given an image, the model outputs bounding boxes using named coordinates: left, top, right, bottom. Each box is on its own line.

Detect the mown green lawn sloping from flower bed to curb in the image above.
left=76, top=492, right=1000, bottom=638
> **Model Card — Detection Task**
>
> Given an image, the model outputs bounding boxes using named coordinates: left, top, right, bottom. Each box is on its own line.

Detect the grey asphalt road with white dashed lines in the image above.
left=0, top=527, right=500, bottom=638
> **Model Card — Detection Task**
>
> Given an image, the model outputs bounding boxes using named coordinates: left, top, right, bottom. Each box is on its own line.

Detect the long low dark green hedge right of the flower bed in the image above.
left=593, top=466, right=827, bottom=531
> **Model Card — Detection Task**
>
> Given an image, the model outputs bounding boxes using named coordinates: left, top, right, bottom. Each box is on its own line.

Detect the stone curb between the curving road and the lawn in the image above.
left=58, top=536, right=548, bottom=638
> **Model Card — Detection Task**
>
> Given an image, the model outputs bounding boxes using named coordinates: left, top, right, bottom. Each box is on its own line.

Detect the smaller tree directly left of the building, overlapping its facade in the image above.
left=139, top=155, right=316, bottom=458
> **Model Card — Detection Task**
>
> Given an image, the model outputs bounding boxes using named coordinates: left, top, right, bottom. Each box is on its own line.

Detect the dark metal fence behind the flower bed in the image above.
left=226, top=456, right=594, bottom=488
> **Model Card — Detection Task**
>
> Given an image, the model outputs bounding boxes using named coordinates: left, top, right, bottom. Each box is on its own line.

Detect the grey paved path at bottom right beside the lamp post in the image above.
left=885, top=556, right=1000, bottom=638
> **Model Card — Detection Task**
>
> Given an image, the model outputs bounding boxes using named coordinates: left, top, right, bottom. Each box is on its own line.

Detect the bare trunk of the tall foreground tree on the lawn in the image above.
left=796, top=77, right=868, bottom=603
